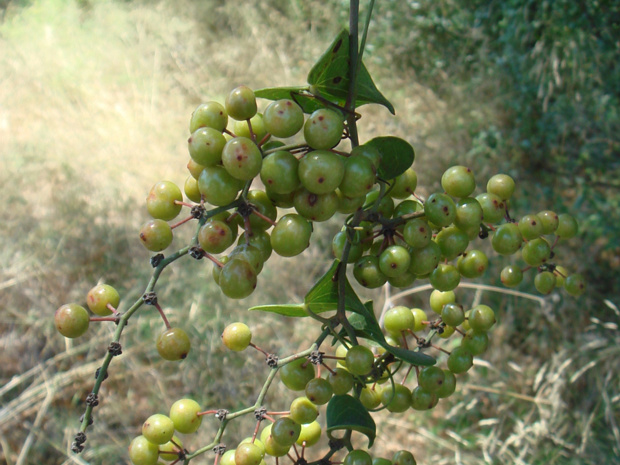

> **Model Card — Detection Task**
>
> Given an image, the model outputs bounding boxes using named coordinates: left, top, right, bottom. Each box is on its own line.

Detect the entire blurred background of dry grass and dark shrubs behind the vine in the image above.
left=0, top=0, right=620, bottom=465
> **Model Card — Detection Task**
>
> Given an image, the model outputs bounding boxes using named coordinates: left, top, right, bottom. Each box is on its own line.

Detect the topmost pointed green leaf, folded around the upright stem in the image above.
left=308, top=29, right=394, bottom=114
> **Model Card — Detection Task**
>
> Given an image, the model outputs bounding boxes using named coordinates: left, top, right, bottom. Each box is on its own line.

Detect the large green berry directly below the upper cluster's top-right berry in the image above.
left=297, top=150, right=345, bottom=194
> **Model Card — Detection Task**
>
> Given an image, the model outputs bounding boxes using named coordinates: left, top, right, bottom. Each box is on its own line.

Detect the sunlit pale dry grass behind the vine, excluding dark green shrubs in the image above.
left=0, top=0, right=620, bottom=465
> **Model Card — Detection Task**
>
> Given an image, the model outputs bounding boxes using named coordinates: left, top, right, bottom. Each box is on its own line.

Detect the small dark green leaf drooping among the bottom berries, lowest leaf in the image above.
left=326, top=395, right=377, bottom=448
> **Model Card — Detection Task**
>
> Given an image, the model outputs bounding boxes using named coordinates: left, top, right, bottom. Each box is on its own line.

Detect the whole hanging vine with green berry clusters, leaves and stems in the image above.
left=55, top=2, right=585, bottom=465
